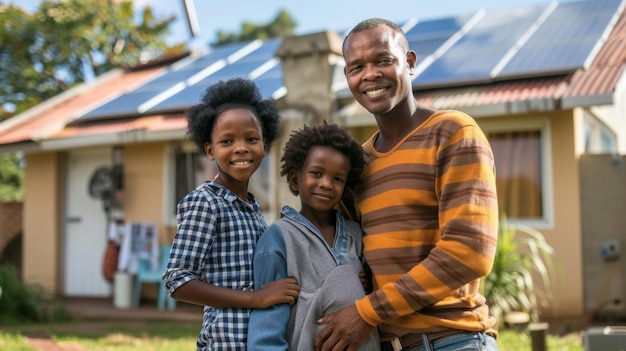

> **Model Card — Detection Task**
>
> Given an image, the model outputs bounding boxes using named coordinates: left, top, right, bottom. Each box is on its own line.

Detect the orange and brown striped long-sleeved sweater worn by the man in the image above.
left=356, top=111, right=498, bottom=340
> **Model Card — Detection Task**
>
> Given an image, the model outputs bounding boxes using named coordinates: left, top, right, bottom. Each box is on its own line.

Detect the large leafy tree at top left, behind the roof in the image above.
left=0, top=0, right=181, bottom=121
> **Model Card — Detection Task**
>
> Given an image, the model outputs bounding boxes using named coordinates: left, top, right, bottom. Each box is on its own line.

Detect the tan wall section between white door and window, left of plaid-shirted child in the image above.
left=124, top=143, right=171, bottom=243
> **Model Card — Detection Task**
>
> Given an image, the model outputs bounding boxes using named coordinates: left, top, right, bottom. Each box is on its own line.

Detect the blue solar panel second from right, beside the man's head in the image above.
left=413, top=6, right=546, bottom=86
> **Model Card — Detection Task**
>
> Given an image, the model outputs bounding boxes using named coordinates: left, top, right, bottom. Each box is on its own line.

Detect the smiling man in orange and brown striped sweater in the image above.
left=315, top=19, right=498, bottom=351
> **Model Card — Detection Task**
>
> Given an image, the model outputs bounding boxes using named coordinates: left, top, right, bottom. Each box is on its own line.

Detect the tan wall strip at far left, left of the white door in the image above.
left=22, top=153, right=62, bottom=293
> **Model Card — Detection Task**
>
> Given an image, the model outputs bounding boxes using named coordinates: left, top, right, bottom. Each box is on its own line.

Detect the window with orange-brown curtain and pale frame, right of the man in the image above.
left=481, top=121, right=552, bottom=227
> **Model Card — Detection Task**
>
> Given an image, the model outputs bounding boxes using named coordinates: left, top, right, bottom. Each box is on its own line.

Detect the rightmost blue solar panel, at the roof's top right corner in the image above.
left=500, top=0, right=621, bottom=77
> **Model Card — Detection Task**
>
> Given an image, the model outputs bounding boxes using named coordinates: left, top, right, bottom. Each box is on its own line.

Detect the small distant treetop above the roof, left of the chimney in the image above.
left=211, top=9, right=298, bottom=46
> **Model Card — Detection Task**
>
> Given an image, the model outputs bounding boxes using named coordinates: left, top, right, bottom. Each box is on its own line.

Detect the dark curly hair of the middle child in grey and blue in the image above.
left=280, top=121, right=365, bottom=195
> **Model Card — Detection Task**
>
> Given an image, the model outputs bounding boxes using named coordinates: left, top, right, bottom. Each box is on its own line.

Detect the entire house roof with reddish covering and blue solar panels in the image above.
left=0, top=0, right=626, bottom=151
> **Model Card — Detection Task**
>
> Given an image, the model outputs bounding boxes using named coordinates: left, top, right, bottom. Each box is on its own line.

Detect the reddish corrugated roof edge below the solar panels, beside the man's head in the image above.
left=340, top=0, right=626, bottom=121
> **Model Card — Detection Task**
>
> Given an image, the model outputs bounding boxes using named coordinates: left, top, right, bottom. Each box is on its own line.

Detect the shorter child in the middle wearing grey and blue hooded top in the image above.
left=248, top=123, right=380, bottom=351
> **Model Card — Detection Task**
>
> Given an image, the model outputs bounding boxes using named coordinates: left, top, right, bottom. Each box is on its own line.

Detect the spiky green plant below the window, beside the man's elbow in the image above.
left=482, top=216, right=554, bottom=327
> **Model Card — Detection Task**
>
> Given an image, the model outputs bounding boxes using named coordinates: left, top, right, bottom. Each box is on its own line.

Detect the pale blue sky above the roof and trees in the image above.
left=0, top=0, right=576, bottom=49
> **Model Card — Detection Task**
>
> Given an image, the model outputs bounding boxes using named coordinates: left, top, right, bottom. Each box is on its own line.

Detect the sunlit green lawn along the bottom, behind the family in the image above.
left=0, top=321, right=584, bottom=351
